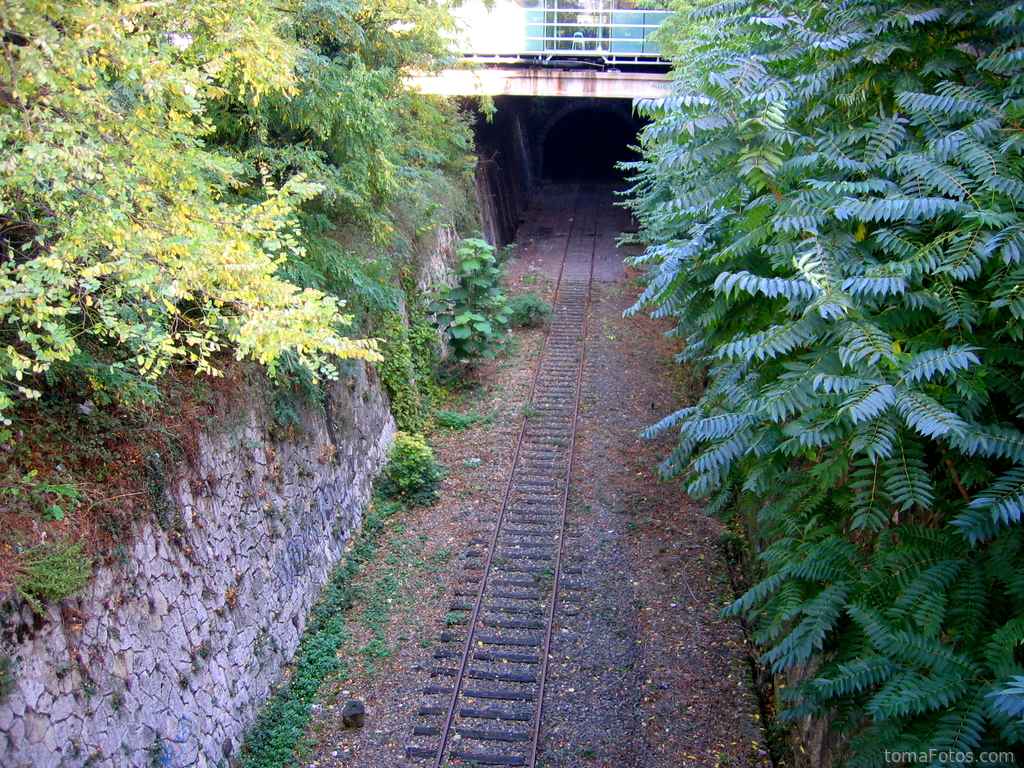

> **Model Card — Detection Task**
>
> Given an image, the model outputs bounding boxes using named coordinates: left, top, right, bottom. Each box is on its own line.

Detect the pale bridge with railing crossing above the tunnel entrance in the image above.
left=407, top=0, right=669, bottom=98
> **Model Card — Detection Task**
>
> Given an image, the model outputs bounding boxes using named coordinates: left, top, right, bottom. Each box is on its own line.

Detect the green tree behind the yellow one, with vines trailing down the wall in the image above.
left=201, top=0, right=474, bottom=431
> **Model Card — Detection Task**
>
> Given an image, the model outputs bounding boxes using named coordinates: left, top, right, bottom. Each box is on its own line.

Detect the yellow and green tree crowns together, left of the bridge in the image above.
left=0, top=0, right=472, bottom=418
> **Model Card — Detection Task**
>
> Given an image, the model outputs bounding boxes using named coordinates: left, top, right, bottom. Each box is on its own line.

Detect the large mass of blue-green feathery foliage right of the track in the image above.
left=633, top=0, right=1024, bottom=766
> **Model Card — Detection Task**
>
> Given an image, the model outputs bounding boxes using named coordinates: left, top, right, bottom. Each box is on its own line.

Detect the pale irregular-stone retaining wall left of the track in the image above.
left=0, top=365, right=394, bottom=768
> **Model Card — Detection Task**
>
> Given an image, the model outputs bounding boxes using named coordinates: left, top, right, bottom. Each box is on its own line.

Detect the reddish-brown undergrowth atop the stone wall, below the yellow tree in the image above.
left=0, top=371, right=209, bottom=596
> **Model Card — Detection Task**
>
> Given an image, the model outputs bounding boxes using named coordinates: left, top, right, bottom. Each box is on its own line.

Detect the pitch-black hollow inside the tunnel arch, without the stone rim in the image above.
left=543, top=108, right=637, bottom=182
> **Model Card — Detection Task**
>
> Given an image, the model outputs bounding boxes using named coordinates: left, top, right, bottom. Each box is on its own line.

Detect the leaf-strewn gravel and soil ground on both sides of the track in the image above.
left=303, top=188, right=769, bottom=768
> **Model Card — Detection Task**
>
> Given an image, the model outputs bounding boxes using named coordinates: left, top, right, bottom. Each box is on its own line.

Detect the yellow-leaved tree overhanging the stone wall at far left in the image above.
left=0, top=0, right=385, bottom=421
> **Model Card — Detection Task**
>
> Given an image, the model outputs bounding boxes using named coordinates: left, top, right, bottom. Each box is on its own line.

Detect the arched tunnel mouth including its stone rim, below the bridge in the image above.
left=534, top=98, right=643, bottom=178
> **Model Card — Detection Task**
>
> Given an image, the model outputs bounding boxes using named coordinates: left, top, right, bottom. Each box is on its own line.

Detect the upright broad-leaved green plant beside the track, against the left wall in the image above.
left=429, top=238, right=509, bottom=364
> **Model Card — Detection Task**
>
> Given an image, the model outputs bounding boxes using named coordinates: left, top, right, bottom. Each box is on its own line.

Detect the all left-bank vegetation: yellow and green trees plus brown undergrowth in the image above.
left=0, top=0, right=476, bottom=602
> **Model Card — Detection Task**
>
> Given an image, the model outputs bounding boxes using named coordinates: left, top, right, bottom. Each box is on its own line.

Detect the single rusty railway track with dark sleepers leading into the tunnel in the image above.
left=406, top=186, right=600, bottom=768
